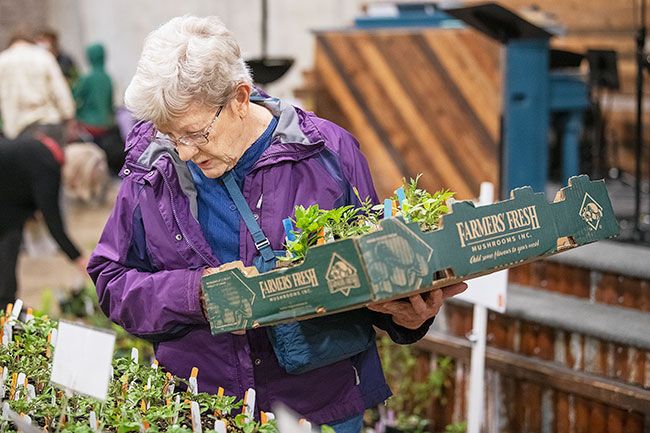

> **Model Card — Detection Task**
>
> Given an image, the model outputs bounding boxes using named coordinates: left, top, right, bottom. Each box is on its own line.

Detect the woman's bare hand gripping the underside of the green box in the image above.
left=368, top=283, right=467, bottom=329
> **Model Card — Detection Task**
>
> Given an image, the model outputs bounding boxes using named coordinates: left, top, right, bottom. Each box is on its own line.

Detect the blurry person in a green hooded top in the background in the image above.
left=73, top=44, right=124, bottom=175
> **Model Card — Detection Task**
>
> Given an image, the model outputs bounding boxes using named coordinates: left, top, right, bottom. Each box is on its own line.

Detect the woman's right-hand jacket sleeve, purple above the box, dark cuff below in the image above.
left=332, top=123, right=433, bottom=344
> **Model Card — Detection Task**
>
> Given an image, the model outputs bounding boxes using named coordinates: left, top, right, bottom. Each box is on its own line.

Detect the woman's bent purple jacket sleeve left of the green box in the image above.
left=88, top=181, right=207, bottom=340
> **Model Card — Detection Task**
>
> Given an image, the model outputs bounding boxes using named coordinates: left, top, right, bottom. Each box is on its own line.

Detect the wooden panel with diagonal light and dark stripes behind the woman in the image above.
left=315, top=29, right=501, bottom=198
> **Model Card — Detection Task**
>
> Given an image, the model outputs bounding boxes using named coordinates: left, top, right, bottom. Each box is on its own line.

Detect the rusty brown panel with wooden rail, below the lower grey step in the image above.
left=418, top=304, right=650, bottom=433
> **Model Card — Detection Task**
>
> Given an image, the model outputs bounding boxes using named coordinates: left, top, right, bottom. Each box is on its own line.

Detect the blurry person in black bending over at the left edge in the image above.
left=0, top=136, right=87, bottom=305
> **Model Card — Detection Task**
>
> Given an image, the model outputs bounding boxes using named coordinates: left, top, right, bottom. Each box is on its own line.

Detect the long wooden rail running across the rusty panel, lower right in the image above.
left=417, top=333, right=650, bottom=415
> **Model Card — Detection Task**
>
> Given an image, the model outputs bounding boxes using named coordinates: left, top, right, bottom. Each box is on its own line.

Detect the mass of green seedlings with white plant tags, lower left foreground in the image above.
left=0, top=316, right=277, bottom=433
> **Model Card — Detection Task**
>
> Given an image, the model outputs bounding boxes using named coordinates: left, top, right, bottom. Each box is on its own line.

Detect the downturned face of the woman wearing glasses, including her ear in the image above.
left=160, top=86, right=250, bottom=179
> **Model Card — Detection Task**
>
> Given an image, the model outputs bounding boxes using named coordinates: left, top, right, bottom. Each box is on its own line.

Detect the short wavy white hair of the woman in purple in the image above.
left=124, top=15, right=252, bottom=126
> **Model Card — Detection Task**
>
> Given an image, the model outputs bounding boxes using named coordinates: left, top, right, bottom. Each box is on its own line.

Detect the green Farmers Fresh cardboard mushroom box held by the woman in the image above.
left=202, top=176, right=619, bottom=334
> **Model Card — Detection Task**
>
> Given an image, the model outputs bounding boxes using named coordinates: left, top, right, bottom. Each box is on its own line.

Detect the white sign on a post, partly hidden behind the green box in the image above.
left=455, top=182, right=508, bottom=313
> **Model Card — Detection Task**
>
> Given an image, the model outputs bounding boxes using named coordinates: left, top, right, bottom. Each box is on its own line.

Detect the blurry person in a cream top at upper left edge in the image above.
left=0, top=32, right=75, bottom=144
